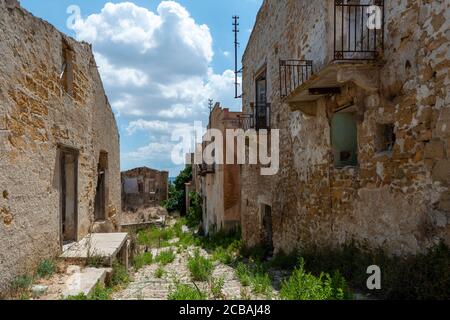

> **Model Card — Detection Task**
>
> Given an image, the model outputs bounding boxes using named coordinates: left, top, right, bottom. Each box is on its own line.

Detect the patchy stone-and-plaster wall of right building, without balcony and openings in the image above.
left=241, top=0, right=450, bottom=253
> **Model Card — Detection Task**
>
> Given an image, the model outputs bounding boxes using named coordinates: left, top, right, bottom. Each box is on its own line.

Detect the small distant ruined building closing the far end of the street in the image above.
left=122, top=167, right=169, bottom=211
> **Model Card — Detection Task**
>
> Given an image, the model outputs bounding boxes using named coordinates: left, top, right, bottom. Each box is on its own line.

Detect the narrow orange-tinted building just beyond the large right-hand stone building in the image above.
left=193, top=103, right=241, bottom=234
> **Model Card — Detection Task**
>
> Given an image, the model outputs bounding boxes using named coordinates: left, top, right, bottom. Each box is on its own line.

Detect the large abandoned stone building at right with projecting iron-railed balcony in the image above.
left=241, top=0, right=450, bottom=254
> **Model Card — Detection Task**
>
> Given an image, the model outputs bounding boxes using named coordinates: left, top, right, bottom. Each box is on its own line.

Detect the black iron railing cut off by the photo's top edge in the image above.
left=334, top=0, right=384, bottom=60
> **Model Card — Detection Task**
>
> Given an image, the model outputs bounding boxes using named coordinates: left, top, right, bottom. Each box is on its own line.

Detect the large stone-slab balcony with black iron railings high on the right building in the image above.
left=279, top=0, right=384, bottom=116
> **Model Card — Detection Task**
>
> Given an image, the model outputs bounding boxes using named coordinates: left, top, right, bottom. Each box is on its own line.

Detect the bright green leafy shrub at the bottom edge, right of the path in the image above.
left=280, top=259, right=347, bottom=300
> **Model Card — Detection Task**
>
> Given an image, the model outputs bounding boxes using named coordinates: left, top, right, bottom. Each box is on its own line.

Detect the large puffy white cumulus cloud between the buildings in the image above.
left=74, top=1, right=239, bottom=172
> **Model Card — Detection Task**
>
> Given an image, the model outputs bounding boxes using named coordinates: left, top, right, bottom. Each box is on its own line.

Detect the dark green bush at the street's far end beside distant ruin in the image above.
left=163, top=166, right=192, bottom=213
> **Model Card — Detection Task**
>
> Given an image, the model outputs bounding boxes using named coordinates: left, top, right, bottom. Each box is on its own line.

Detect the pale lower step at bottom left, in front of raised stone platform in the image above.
left=62, top=268, right=111, bottom=298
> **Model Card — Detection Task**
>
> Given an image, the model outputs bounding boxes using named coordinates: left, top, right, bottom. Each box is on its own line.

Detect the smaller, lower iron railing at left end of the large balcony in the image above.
left=279, top=60, right=313, bottom=99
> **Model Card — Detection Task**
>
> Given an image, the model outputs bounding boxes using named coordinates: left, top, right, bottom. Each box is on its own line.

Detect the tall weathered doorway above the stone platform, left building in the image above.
left=59, top=148, right=78, bottom=245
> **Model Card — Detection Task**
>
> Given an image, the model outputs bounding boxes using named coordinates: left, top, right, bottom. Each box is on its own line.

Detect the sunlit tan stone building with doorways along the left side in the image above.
left=0, top=0, right=121, bottom=293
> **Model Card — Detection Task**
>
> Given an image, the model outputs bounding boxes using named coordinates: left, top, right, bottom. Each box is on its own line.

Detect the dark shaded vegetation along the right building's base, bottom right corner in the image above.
left=301, top=242, right=450, bottom=300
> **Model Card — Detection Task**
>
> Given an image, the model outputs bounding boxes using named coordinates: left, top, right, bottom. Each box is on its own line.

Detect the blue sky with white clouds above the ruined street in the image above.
left=21, top=0, right=262, bottom=176
